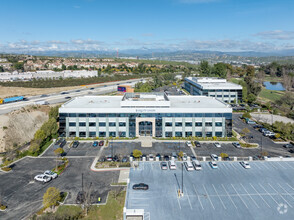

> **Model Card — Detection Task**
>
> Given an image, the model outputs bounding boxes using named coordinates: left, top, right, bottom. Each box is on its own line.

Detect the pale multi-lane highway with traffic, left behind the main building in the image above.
left=0, top=79, right=145, bottom=115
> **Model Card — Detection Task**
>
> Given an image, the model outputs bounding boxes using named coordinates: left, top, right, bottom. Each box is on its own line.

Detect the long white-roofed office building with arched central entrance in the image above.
left=59, top=93, right=232, bottom=137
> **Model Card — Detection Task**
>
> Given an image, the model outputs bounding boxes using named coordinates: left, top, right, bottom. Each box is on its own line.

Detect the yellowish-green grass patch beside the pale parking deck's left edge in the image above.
left=85, top=191, right=126, bottom=220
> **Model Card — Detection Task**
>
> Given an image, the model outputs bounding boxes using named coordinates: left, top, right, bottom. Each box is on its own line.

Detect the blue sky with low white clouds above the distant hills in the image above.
left=0, top=0, right=294, bottom=53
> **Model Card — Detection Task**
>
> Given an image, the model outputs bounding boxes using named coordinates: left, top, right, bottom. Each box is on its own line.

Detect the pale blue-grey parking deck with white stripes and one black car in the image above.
left=126, top=161, right=294, bottom=219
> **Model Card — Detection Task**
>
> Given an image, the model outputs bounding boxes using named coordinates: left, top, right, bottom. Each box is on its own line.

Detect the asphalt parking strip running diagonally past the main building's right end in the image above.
left=233, top=114, right=291, bottom=156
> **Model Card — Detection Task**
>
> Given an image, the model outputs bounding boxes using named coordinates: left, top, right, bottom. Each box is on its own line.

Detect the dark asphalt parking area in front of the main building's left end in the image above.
left=43, top=142, right=101, bottom=157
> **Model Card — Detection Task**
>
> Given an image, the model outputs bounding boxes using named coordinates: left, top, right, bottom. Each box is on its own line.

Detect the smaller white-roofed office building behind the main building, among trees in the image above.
left=184, top=77, right=242, bottom=103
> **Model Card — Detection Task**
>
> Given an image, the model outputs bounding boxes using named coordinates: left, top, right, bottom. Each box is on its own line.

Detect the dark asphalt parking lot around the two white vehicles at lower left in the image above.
left=0, top=157, right=119, bottom=219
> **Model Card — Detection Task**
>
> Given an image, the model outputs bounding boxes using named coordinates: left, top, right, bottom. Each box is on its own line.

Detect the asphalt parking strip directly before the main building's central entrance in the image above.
left=102, top=142, right=193, bottom=157
